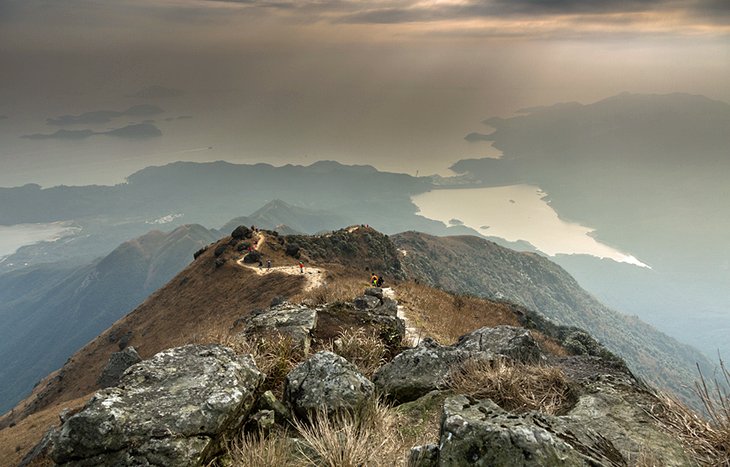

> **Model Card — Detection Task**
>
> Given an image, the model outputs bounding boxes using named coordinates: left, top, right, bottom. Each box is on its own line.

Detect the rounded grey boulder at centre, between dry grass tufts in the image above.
left=284, top=351, right=374, bottom=418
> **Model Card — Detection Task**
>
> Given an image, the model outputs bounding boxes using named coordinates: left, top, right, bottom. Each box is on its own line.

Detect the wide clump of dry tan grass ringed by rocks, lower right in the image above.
left=449, top=359, right=575, bottom=415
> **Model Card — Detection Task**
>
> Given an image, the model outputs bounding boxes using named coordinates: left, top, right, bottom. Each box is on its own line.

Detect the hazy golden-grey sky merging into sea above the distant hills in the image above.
left=0, top=0, right=730, bottom=186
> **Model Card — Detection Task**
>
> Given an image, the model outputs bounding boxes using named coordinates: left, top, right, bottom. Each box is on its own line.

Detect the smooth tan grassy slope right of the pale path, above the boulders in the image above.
left=397, top=282, right=520, bottom=344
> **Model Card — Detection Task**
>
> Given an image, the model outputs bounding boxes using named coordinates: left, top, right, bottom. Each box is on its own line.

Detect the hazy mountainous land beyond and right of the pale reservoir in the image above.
left=453, top=94, right=730, bottom=359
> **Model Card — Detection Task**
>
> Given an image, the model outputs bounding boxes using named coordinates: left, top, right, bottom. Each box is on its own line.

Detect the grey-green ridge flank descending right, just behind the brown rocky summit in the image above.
left=391, top=232, right=713, bottom=406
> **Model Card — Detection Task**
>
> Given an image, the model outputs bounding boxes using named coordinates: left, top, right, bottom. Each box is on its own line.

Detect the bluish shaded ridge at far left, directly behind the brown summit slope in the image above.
left=0, top=225, right=218, bottom=412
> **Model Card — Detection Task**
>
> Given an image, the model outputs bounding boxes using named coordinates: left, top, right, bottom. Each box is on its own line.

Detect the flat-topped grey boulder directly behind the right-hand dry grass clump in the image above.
left=456, top=326, right=542, bottom=363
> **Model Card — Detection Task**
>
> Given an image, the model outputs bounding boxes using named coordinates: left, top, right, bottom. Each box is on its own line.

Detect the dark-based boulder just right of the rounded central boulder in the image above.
left=373, top=337, right=474, bottom=402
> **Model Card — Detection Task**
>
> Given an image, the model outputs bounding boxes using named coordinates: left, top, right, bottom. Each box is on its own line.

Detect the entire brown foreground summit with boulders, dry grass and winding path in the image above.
left=0, top=226, right=718, bottom=467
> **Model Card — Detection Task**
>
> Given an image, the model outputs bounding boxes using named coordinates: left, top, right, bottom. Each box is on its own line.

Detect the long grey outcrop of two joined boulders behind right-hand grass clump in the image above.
left=373, top=326, right=542, bottom=402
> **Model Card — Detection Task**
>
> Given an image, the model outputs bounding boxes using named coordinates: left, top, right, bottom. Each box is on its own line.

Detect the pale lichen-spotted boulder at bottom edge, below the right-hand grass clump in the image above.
left=438, top=396, right=596, bottom=467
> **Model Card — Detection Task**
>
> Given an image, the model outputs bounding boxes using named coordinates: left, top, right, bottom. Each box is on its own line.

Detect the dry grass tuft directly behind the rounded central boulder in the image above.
left=324, top=328, right=388, bottom=378
